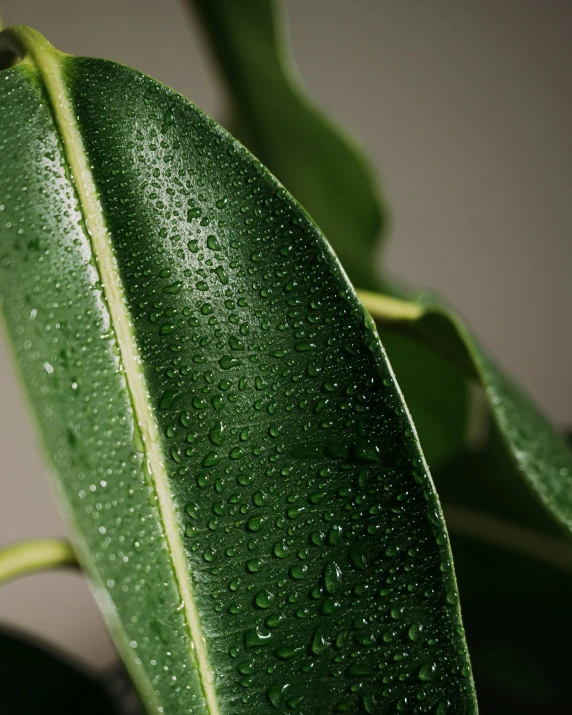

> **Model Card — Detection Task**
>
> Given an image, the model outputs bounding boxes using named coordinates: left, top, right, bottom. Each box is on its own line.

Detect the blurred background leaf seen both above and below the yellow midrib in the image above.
left=191, top=0, right=470, bottom=466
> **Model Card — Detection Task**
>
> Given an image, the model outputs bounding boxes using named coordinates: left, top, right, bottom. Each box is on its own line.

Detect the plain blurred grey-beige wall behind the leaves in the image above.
left=0, top=0, right=572, bottom=666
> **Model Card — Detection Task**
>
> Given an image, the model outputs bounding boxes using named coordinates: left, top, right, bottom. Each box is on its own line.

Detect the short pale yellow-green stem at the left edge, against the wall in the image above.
left=0, top=539, right=77, bottom=585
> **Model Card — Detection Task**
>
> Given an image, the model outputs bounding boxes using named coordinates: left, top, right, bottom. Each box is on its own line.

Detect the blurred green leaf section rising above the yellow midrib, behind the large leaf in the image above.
left=192, top=0, right=387, bottom=290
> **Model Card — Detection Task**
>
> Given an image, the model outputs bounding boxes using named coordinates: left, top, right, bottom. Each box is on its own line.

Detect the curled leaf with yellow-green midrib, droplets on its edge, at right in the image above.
left=360, top=292, right=572, bottom=536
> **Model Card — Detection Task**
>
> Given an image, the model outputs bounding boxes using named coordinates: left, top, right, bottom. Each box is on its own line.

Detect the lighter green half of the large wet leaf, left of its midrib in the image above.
left=0, top=60, right=210, bottom=711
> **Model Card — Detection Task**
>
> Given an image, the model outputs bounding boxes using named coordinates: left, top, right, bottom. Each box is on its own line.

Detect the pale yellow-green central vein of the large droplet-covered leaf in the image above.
left=29, top=37, right=220, bottom=715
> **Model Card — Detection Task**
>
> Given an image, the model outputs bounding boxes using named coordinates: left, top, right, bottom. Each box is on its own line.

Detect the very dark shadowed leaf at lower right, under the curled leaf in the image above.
left=435, top=444, right=572, bottom=713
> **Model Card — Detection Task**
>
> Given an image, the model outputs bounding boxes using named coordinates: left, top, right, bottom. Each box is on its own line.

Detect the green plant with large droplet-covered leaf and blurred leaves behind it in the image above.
left=1, top=2, right=570, bottom=713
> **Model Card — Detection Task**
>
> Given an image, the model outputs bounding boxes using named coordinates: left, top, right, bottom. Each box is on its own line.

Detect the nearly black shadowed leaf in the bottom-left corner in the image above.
left=0, top=630, right=118, bottom=715
